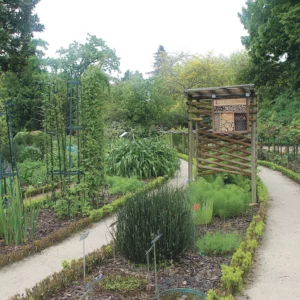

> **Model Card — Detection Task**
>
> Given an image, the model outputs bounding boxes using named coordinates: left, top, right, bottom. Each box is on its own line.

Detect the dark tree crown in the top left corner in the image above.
left=0, top=0, right=44, bottom=72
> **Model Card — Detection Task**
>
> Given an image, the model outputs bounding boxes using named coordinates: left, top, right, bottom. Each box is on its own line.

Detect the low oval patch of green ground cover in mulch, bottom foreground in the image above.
left=99, top=275, right=147, bottom=292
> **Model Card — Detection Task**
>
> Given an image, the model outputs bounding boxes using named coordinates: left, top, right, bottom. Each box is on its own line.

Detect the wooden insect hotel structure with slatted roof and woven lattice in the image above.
left=185, top=84, right=257, bottom=202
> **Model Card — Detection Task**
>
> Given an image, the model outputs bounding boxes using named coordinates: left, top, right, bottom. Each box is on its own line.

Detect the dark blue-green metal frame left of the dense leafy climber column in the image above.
left=45, top=74, right=85, bottom=215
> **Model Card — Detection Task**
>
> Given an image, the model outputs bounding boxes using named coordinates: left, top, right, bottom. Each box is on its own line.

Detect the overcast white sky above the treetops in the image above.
left=36, top=0, right=246, bottom=72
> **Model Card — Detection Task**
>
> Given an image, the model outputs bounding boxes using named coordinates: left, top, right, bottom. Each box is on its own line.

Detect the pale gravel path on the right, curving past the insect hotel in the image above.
left=235, top=167, right=300, bottom=300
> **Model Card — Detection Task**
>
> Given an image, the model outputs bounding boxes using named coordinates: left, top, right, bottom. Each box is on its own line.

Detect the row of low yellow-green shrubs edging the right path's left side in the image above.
left=206, top=172, right=268, bottom=300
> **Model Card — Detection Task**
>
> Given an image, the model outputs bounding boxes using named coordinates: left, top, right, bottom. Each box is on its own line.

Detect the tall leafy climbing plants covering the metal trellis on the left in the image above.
left=44, top=67, right=109, bottom=217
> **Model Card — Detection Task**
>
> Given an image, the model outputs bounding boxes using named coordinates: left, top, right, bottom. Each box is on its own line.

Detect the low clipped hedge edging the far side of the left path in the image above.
left=0, top=175, right=169, bottom=269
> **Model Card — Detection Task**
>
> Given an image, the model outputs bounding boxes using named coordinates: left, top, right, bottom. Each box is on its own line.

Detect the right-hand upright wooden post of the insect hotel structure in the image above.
left=251, top=96, right=257, bottom=203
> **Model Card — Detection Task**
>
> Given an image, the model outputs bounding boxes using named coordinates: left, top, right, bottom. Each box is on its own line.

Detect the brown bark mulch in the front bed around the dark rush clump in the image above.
left=51, top=206, right=258, bottom=300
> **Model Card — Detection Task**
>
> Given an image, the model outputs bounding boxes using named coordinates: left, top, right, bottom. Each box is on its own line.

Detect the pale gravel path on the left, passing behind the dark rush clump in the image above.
left=0, top=160, right=188, bottom=300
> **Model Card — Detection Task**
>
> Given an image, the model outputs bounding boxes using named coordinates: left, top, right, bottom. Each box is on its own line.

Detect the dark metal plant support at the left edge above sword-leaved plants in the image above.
left=0, top=100, right=22, bottom=205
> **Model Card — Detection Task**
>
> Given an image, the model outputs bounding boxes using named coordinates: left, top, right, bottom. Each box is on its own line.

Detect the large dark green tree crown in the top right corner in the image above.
left=239, top=0, right=300, bottom=90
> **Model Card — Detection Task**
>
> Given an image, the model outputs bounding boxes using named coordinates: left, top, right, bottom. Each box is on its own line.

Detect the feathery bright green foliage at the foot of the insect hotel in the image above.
left=188, top=176, right=251, bottom=218
